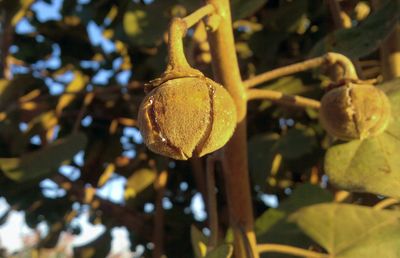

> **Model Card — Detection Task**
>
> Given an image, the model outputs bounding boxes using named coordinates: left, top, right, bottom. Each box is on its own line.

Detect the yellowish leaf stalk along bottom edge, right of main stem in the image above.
left=257, top=244, right=329, bottom=258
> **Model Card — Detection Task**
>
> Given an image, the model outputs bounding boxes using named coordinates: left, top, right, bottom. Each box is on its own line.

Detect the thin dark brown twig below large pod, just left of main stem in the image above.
left=206, top=155, right=219, bottom=252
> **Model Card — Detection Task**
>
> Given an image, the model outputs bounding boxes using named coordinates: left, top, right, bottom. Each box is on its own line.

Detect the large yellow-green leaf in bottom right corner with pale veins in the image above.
left=290, top=203, right=400, bottom=258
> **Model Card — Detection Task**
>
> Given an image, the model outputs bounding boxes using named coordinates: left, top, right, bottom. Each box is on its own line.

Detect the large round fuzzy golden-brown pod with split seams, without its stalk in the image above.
left=138, top=77, right=236, bottom=160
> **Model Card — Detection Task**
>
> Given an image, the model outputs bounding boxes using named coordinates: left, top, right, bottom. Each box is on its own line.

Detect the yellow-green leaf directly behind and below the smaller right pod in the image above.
left=325, top=80, right=400, bottom=197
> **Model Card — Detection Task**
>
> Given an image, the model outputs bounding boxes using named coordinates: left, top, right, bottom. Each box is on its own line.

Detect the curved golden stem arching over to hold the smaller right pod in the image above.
left=243, top=53, right=358, bottom=88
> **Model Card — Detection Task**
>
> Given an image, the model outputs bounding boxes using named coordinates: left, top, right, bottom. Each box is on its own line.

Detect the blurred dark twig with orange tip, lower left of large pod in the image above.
left=153, top=170, right=168, bottom=258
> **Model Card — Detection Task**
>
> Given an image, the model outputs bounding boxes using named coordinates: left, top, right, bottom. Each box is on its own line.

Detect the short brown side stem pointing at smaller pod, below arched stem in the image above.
left=247, top=89, right=321, bottom=109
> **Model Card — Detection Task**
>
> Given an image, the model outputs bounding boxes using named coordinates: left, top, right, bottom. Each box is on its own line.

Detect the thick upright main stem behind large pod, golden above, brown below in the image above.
left=206, top=0, right=259, bottom=258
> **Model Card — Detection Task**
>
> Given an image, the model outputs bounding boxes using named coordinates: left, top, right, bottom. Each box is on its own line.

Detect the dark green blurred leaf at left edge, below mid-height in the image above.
left=0, top=133, right=86, bottom=182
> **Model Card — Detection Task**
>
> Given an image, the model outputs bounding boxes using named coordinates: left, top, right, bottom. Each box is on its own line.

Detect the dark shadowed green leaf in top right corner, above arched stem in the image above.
left=310, top=0, right=400, bottom=58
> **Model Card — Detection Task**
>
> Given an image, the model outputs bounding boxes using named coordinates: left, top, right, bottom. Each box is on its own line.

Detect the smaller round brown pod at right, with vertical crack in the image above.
left=319, top=83, right=391, bottom=141
